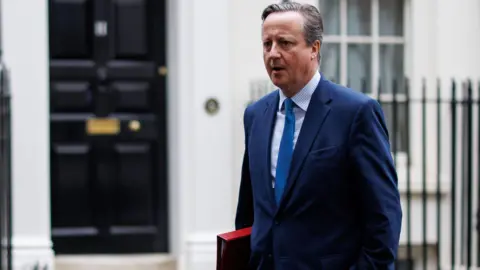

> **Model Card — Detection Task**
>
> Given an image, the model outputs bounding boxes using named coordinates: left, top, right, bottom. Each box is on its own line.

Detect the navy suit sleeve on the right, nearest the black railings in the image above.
left=350, top=99, right=402, bottom=270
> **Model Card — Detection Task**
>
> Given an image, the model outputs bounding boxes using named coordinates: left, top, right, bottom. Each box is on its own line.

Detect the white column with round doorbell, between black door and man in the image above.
left=169, top=0, right=234, bottom=270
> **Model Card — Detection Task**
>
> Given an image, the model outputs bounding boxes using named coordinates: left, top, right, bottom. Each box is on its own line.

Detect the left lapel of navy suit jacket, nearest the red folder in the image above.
left=256, top=94, right=279, bottom=207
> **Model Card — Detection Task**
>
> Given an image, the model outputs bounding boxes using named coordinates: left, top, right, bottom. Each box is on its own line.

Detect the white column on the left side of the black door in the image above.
left=1, top=0, right=53, bottom=269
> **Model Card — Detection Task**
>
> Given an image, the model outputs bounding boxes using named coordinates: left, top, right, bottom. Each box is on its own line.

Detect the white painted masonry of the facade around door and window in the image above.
left=1, top=0, right=480, bottom=270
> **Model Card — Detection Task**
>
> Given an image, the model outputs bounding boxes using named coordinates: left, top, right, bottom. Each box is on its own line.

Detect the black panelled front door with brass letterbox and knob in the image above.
left=48, top=0, right=168, bottom=254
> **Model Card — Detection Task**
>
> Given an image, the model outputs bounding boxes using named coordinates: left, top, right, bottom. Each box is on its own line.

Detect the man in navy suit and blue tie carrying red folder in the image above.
left=235, top=2, right=402, bottom=270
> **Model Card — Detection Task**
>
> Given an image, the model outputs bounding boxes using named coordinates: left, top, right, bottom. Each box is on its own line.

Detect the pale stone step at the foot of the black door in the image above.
left=55, top=254, right=176, bottom=270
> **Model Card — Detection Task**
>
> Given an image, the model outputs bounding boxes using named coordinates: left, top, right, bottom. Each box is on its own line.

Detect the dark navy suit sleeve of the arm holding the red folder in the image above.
left=235, top=108, right=253, bottom=230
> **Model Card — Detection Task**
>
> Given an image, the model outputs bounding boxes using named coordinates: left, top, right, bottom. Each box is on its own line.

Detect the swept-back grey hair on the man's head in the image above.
left=262, top=2, right=323, bottom=62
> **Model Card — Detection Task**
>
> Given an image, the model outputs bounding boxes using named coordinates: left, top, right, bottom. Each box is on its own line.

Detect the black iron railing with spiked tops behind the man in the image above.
left=250, top=79, right=480, bottom=269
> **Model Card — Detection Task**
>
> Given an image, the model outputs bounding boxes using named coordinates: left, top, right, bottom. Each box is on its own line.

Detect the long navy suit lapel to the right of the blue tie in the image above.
left=278, top=75, right=331, bottom=210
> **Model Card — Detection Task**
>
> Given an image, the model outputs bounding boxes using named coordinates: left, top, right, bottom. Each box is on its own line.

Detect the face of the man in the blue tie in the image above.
left=262, top=11, right=319, bottom=94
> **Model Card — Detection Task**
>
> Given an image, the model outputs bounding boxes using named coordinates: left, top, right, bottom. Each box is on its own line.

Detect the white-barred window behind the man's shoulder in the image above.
left=319, top=0, right=408, bottom=152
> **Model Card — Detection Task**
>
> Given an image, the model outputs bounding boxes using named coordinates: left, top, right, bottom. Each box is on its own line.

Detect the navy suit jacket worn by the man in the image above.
left=235, top=76, right=402, bottom=270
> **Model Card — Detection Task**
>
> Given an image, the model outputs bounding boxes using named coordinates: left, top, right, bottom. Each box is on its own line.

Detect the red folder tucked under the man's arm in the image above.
left=217, top=227, right=252, bottom=270
